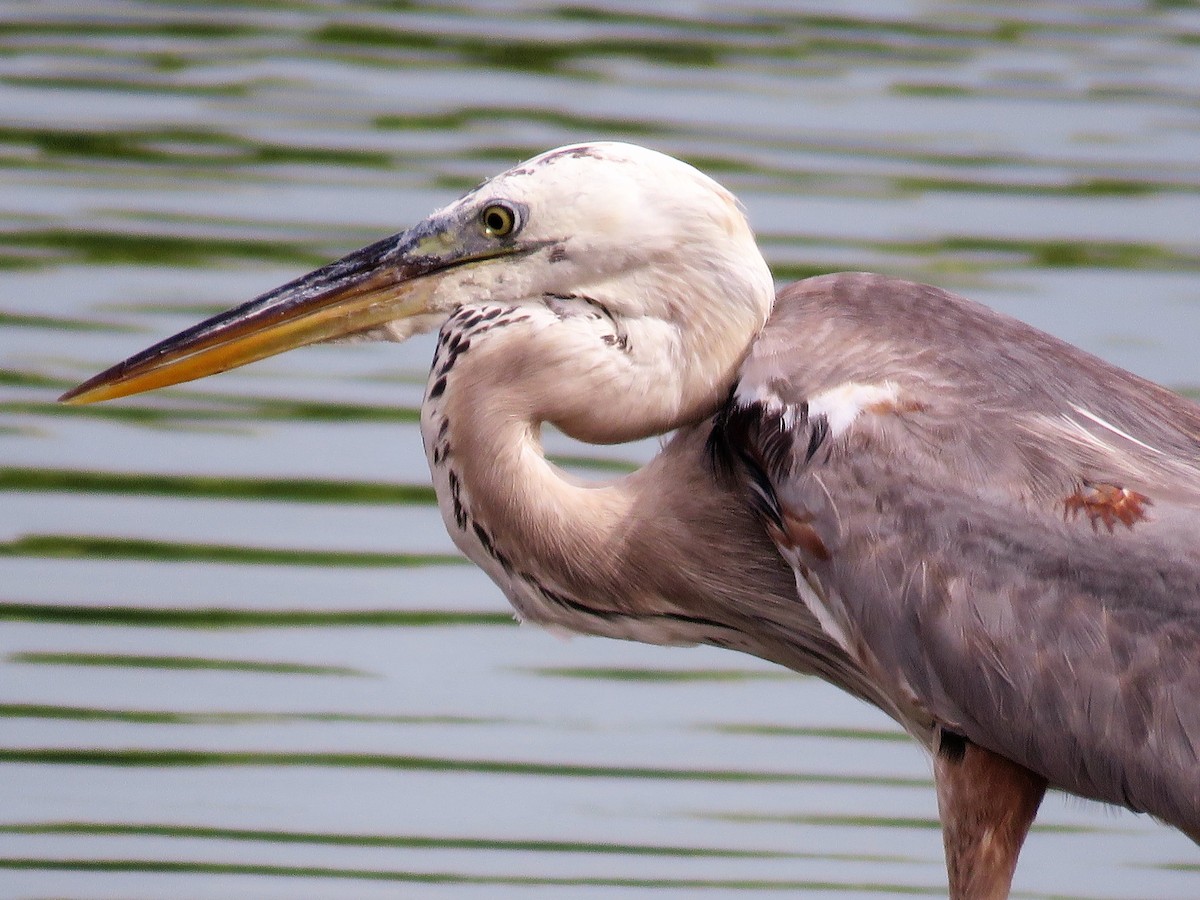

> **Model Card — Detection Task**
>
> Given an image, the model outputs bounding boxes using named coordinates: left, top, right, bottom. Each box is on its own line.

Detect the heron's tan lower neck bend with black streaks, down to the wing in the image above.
left=422, top=340, right=878, bottom=702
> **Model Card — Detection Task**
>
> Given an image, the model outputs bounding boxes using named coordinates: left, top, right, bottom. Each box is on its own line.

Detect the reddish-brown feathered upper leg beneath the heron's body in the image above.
left=934, top=730, right=1046, bottom=900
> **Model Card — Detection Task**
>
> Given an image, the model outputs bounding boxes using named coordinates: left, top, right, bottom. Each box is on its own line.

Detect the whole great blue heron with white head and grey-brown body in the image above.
left=64, top=143, right=1200, bottom=898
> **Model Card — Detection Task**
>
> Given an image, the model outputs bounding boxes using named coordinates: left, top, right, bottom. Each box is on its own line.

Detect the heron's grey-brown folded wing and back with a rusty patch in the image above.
left=721, top=275, right=1200, bottom=834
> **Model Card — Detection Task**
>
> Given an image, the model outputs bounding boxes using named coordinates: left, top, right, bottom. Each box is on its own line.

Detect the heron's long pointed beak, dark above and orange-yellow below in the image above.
left=59, top=223, right=463, bottom=403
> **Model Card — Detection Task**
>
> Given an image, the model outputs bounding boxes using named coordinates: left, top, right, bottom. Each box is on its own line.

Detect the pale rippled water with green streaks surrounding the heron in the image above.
left=0, top=0, right=1200, bottom=900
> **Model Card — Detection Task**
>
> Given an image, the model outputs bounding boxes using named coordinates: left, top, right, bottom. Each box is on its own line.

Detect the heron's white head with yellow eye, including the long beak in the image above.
left=62, top=143, right=774, bottom=422
